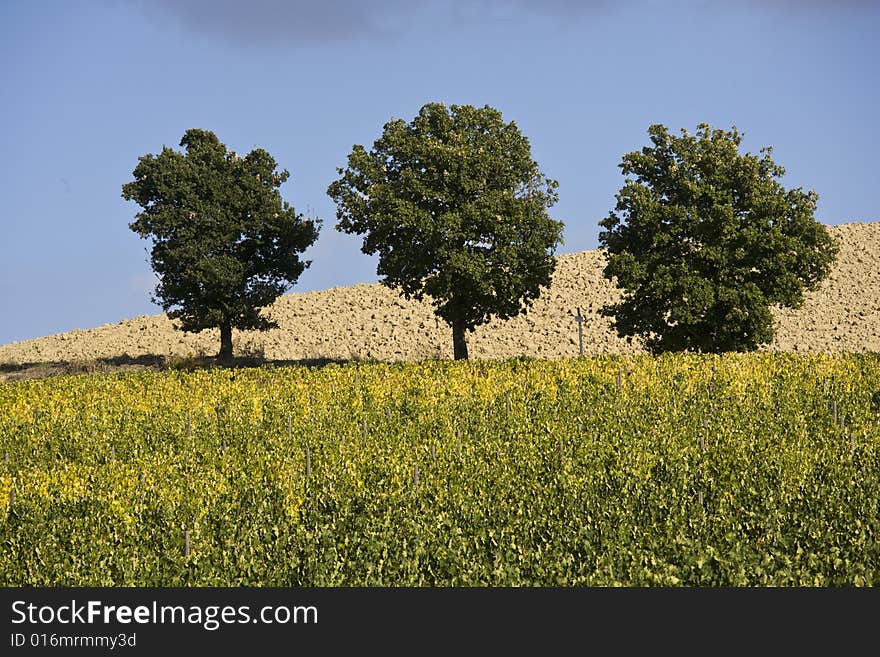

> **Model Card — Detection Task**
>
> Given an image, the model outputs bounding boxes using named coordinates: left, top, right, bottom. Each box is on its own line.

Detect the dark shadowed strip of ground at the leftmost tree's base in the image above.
left=0, top=354, right=350, bottom=382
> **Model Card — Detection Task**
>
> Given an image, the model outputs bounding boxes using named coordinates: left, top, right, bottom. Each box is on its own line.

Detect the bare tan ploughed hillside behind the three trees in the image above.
left=0, top=222, right=880, bottom=371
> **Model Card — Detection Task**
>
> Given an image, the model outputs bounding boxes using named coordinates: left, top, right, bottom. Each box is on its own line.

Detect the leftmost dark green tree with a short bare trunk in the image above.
left=122, top=129, right=320, bottom=361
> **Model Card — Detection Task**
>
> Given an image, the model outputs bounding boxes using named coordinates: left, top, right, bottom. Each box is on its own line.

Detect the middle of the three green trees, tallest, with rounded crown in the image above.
left=327, top=103, right=562, bottom=359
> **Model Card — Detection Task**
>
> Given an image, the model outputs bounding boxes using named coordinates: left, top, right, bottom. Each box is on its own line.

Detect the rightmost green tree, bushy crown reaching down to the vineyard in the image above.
left=599, top=123, right=838, bottom=353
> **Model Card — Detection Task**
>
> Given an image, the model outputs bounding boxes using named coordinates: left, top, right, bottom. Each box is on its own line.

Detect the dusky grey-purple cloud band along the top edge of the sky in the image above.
left=113, top=0, right=880, bottom=47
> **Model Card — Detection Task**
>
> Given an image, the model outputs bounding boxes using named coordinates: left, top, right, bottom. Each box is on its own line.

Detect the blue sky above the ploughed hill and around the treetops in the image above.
left=0, top=0, right=880, bottom=344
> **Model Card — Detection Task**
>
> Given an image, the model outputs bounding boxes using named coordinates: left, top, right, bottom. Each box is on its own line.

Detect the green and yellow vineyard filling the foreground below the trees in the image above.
left=0, top=353, right=880, bottom=587
